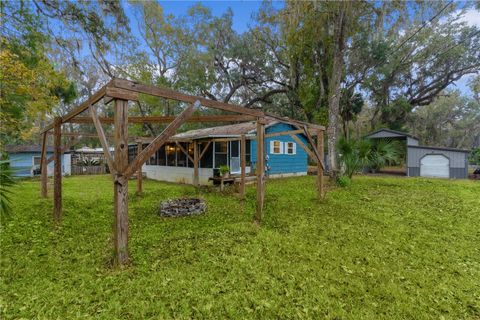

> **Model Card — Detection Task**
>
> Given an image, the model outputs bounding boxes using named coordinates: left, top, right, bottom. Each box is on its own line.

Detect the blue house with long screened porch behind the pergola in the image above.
left=129, top=121, right=308, bottom=184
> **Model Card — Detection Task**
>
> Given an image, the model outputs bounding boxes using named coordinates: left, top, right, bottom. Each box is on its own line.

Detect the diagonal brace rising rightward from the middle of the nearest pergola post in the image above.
left=124, top=101, right=200, bottom=178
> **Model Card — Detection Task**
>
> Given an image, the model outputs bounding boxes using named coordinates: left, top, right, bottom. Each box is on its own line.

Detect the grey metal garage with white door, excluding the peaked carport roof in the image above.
left=407, top=146, right=468, bottom=179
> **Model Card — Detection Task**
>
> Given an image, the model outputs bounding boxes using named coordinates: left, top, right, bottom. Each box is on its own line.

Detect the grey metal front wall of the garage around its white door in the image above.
left=407, top=147, right=468, bottom=179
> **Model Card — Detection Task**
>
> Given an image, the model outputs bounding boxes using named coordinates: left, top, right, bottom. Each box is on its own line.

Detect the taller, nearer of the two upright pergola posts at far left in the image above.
left=53, top=117, right=62, bottom=224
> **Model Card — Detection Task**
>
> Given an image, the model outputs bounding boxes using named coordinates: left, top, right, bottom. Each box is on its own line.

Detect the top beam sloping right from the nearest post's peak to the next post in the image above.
left=113, top=79, right=264, bottom=117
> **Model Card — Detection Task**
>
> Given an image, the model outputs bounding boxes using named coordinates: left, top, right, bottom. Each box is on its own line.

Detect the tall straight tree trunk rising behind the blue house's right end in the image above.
left=327, top=2, right=348, bottom=178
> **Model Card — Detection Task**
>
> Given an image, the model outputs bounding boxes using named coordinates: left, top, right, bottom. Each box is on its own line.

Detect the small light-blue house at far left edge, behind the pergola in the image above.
left=5, top=144, right=63, bottom=177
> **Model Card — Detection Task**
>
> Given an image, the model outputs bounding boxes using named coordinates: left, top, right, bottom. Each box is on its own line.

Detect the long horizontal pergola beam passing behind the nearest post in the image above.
left=67, top=114, right=256, bottom=124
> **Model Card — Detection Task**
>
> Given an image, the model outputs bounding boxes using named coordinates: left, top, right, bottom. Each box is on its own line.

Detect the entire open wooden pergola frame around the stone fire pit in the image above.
left=41, top=78, right=325, bottom=264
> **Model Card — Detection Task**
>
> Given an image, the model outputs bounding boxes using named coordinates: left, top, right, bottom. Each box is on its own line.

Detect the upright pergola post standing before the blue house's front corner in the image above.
left=255, top=119, right=265, bottom=224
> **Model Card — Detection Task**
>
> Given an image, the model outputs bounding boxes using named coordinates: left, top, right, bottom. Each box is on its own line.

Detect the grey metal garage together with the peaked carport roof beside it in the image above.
left=365, top=129, right=469, bottom=179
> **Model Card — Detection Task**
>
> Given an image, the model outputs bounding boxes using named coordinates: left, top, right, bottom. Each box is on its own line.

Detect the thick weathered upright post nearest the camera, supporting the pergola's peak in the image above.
left=113, top=99, right=129, bottom=265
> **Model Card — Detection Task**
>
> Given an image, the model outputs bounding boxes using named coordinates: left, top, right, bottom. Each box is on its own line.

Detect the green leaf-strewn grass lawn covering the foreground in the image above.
left=0, top=176, right=480, bottom=319
